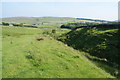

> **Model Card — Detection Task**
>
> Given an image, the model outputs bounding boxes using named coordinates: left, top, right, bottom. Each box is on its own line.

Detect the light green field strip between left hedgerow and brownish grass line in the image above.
left=2, top=26, right=44, bottom=37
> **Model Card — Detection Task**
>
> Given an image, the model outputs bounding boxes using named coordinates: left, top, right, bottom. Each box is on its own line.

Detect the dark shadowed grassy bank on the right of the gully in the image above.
left=60, top=28, right=120, bottom=77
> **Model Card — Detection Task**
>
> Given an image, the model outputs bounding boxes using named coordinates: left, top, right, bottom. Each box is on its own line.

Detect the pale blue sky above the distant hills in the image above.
left=0, top=0, right=118, bottom=21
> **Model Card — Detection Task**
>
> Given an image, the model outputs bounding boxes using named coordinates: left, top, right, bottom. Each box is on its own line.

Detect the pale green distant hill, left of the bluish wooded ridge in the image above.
left=2, top=17, right=76, bottom=24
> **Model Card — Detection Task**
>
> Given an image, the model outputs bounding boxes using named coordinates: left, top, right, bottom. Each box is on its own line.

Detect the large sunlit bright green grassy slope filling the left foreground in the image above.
left=3, top=27, right=112, bottom=78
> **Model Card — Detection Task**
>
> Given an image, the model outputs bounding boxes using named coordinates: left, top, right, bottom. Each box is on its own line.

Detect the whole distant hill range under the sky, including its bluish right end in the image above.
left=2, top=17, right=106, bottom=24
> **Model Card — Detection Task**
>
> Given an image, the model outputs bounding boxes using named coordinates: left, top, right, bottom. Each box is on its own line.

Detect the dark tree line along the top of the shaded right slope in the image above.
left=60, top=22, right=120, bottom=30
